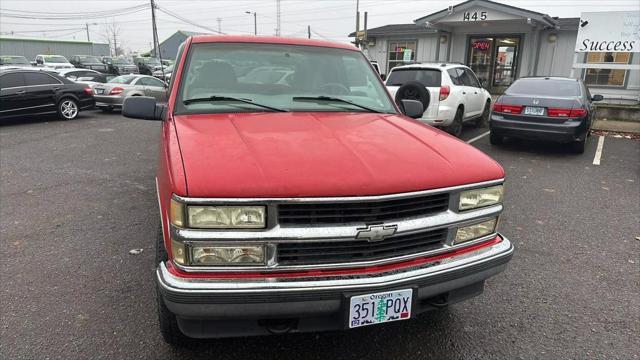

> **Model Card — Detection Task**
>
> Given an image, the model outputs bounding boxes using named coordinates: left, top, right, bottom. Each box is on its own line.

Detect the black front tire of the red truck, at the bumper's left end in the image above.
left=156, top=226, right=193, bottom=347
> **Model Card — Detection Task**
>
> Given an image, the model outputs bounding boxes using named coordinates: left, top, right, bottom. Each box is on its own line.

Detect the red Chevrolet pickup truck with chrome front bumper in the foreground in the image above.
left=123, top=36, right=513, bottom=345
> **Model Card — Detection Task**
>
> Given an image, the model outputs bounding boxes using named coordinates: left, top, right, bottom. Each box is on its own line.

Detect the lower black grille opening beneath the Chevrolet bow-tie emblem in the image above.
left=278, top=229, right=447, bottom=265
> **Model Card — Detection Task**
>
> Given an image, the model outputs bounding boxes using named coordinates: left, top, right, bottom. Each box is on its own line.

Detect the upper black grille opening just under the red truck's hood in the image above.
left=278, top=193, right=449, bottom=226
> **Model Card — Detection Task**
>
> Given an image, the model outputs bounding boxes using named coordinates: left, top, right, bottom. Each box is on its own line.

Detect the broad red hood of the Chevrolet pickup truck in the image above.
left=174, top=112, right=504, bottom=197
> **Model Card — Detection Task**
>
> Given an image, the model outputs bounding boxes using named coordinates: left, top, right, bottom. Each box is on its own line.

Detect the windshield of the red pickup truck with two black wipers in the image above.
left=176, top=43, right=396, bottom=114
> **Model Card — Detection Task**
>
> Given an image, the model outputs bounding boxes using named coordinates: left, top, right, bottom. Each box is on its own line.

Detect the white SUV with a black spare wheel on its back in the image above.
left=386, top=63, right=491, bottom=136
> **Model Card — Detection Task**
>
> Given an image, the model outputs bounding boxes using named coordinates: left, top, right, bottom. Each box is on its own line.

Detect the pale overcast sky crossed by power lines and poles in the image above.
left=0, top=0, right=640, bottom=51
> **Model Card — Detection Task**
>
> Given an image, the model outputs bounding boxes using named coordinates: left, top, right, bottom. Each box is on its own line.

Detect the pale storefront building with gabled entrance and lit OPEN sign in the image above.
left=350, top=0, right=640, bottom=103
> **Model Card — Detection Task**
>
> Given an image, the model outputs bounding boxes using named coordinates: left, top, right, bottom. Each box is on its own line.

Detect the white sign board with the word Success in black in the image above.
left=575, top=11, right=640, bottom=52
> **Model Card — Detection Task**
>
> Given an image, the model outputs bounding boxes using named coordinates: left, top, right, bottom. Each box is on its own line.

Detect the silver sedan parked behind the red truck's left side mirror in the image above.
left=93, top=75, right=167, bottom=111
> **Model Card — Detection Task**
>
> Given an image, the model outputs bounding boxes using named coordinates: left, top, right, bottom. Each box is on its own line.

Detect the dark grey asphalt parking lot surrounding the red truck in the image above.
left=0, top=111, right=640, bottom=359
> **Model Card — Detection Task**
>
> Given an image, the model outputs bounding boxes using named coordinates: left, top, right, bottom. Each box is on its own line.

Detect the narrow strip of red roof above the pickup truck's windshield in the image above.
left=192, top=35, right=359, bottom=51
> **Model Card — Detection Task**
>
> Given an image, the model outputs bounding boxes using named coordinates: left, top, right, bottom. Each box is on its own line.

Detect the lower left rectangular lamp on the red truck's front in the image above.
left=191, top=244, right=265, bottom=266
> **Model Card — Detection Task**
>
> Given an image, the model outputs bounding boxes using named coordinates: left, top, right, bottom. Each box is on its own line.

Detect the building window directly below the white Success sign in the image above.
left=584, top=52, right=631, bottom=86
